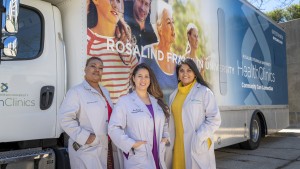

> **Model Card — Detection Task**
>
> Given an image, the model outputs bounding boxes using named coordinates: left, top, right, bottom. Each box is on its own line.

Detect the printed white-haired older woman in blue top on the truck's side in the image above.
left=140, top=0, right=179, bottom=102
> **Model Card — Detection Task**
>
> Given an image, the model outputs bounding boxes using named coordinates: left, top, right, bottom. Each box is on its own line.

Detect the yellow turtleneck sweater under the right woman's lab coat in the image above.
left=171, top=80, right=196, bottom=169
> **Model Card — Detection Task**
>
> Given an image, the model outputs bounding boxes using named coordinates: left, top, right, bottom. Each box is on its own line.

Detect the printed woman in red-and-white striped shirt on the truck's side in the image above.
left=87, top=0, right=138, bottom=104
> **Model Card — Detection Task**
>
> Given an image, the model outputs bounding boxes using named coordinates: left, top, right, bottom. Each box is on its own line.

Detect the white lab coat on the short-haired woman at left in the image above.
left=59, top=80, right=118, bottom=169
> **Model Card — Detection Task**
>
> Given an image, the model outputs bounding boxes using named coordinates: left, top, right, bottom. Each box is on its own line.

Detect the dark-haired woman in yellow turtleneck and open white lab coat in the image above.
left=167, top=59, right=221, bottom=169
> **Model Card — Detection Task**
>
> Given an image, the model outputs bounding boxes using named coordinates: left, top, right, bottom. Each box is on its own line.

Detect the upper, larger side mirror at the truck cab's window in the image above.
left=2, top=0, right=19, bottom=34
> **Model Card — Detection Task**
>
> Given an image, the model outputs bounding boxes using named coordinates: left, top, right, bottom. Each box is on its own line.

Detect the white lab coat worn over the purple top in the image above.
left=108, top=91, right=169, bottom=169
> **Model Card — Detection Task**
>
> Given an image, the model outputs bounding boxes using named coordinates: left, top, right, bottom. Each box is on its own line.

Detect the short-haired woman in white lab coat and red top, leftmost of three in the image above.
left=59, top=57, right=118, bottom=169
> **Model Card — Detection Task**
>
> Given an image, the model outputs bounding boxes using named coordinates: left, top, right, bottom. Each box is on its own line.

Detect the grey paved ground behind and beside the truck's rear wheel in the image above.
left=216, top=127, right=300, bottom=169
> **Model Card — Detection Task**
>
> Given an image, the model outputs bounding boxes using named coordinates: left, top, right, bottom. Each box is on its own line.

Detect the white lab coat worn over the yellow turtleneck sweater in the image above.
left=166, top=83, right=221, bottom=169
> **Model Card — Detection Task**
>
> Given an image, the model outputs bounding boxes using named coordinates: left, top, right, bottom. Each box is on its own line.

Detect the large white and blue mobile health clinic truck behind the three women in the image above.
left=0, top=0, right=289, bottom=169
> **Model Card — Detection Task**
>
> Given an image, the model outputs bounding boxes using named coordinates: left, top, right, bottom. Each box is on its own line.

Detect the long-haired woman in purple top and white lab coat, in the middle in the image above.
left=108, top=63, right=169, bottom=169
